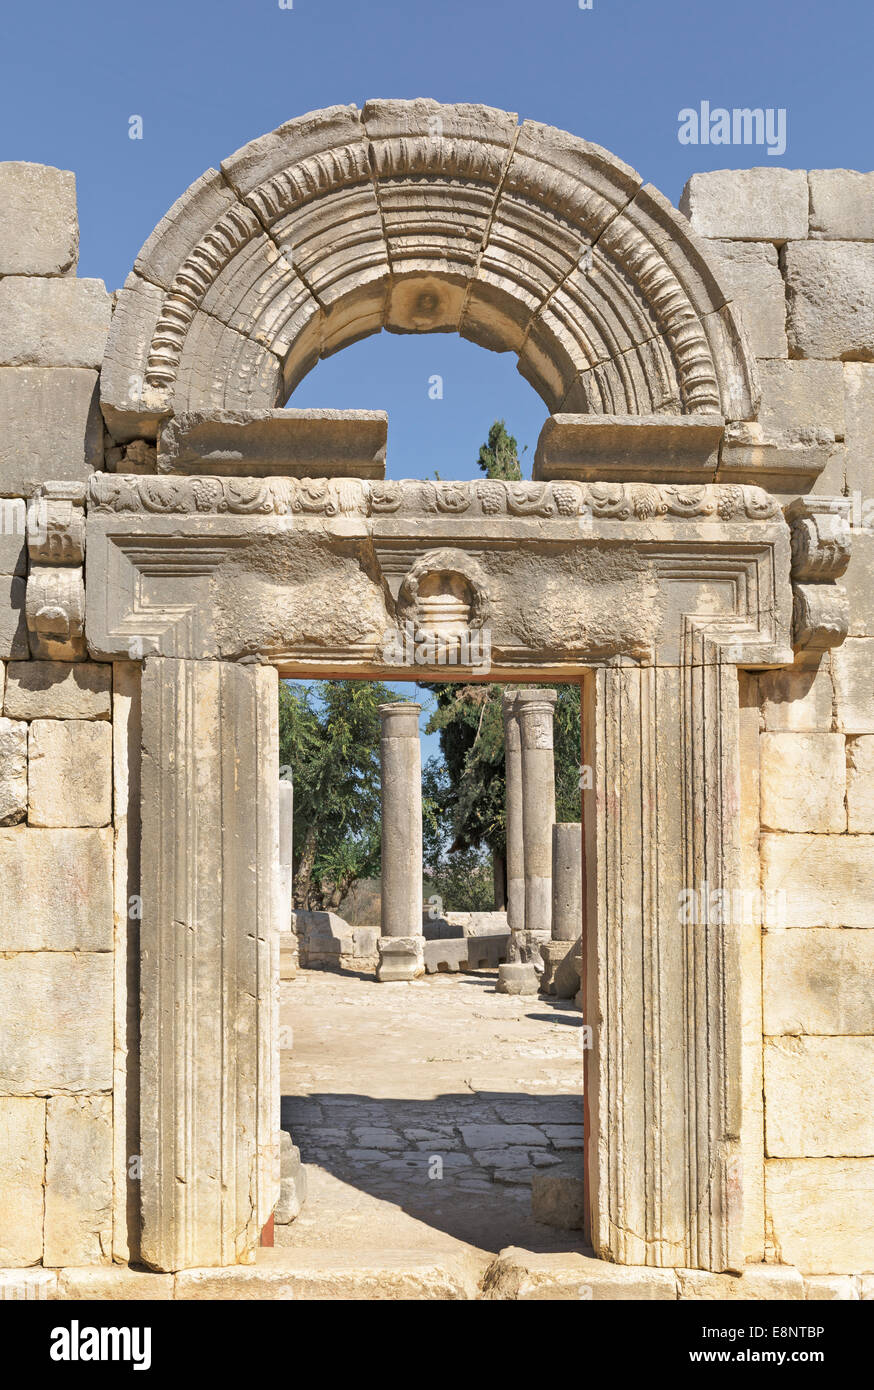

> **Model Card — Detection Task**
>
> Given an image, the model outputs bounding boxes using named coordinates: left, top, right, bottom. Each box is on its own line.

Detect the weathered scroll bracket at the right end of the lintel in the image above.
left=786, top=496, right=850, bottom=652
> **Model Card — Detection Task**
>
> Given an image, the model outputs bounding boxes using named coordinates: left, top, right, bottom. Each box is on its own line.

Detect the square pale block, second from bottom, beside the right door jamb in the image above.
left=764, top=1037, right=874, bottom=1158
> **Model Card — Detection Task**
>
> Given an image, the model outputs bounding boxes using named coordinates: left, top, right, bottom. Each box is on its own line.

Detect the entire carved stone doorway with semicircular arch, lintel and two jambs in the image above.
left=73, top=101, right=839, bottom=1270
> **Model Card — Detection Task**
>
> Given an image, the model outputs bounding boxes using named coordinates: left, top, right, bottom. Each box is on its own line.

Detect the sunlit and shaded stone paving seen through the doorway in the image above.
left=277, top=970, right=584, bottom=1258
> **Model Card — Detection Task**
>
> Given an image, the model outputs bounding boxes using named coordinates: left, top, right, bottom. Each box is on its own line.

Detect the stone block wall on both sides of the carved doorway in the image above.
left=0, top=152, right=874, bottom=1295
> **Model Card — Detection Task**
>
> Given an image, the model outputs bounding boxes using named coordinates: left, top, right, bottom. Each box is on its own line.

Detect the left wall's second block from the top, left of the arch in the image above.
left=0, top=275, right=111, bottom=367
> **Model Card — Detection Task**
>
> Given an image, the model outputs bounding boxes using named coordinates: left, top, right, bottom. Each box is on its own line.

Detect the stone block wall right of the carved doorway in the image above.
left=681, top=168, right=874, bottom=1278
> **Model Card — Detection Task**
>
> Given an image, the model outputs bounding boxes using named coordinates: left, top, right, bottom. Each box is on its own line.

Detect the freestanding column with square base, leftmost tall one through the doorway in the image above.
left=377, top=702, right=424, bottom=980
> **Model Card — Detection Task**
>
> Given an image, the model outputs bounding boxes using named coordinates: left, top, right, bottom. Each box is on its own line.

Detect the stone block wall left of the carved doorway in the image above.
left=0, top=164, right=117, bottom=1268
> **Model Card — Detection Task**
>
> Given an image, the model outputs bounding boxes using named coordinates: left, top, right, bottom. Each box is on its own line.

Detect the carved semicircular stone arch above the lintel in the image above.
left=101, top=99, right=757, bottom=438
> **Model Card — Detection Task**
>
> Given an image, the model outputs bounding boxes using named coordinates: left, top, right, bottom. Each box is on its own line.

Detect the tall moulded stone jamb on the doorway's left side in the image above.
left=140, top=656, right=279, bottom=1270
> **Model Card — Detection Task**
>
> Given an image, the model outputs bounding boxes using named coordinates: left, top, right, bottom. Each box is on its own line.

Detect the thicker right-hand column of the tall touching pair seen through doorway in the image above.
left=516, top=689, right=556, bottom=960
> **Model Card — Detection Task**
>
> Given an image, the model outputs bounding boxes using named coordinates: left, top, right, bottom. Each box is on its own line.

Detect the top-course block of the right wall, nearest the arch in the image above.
left=679, top=168, right=807, bottom=242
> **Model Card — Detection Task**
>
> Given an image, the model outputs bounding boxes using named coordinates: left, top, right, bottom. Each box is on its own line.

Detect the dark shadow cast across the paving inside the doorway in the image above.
left=282, top=1091, right=585, bottom=1252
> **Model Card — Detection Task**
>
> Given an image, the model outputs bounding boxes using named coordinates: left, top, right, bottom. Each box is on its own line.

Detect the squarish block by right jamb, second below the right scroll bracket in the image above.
left=761, top=733, right=846, bottom=833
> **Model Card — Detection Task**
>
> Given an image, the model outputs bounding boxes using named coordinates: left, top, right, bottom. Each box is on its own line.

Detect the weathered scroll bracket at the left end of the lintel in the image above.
left=25, top=482, right=86, bottom=662
